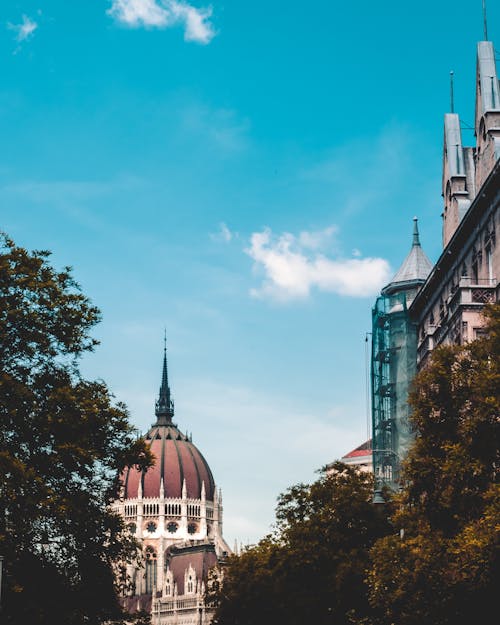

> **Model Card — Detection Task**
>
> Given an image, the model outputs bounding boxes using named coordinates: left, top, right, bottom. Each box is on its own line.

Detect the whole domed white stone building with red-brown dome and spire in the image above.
left=115, top=349, right=230, bottom=625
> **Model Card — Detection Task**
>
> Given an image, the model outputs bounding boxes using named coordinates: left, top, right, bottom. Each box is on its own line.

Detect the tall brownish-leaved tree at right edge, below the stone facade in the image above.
left=369, top=305, right=500, bottom=625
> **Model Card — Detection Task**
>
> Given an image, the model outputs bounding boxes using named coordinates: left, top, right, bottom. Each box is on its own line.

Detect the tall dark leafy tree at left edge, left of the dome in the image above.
left=0, top=235, right=152, bottom=625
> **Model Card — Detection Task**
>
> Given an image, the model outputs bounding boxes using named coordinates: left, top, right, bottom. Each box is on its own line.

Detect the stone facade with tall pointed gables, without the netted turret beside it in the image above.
left=410, top=41, right=500, bottom=368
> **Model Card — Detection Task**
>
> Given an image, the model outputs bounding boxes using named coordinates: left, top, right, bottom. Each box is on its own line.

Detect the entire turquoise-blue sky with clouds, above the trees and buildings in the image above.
left=0, top=0, right=500, bottom=544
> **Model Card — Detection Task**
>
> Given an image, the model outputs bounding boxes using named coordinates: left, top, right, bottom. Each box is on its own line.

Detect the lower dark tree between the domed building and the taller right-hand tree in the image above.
left=215, top=463, right=391, bottom=625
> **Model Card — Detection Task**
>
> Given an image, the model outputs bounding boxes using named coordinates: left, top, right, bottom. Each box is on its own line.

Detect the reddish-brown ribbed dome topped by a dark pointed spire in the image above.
left=123, top=349, right=215, bottom=501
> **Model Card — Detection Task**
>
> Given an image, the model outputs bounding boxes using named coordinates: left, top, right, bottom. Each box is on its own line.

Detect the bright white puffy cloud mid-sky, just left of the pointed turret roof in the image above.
left=245, top=228, right=390, bottom=300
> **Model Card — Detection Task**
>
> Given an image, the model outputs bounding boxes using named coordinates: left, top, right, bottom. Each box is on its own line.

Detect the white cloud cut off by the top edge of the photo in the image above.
left=108, top=0, right=215, bottom=44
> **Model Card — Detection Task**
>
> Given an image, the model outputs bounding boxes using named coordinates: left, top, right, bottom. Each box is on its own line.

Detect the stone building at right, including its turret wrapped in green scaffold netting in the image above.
left=371, top=35, right=500, bottom=488
